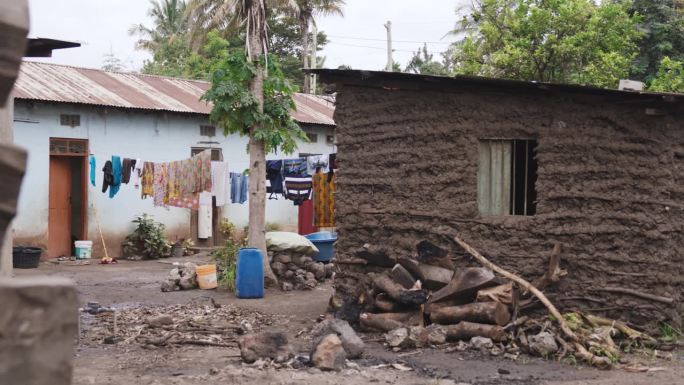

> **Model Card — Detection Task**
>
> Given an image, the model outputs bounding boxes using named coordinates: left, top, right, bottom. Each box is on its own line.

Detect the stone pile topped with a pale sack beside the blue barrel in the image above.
left=266, top=231, right=334, bottom=291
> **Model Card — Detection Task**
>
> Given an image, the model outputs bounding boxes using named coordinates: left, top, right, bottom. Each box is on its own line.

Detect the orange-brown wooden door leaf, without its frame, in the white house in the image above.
left=47, top=156, right=72, bottom=258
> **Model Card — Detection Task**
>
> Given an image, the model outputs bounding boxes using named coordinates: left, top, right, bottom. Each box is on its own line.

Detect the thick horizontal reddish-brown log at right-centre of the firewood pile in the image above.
left=430, top=302, right=511, bottom=326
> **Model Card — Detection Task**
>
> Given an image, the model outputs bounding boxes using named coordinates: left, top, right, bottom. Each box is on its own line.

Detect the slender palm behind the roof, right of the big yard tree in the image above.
left=285, top=0, right=346, bottom=93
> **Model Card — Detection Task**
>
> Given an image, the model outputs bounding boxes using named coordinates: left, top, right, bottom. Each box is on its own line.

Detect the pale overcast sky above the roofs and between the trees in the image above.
left=29, top=0, right=470, bottom=71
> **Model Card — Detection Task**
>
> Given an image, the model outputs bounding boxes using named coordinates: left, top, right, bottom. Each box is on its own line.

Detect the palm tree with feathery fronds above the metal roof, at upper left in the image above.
left=128, top=0, right=187, bottom=53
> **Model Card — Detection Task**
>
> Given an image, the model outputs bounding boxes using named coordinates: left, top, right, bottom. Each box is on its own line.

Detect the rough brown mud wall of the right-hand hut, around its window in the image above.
left=335, top=84, right=684, bottom=326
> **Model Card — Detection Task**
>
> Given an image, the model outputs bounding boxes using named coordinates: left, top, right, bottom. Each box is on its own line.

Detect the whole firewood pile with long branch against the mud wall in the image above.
left=330, top=237, right=657, bottom=368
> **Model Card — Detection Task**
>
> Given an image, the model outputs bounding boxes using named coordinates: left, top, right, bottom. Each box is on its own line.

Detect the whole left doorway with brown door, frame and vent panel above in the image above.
left=47, top=138, right=88, bottom=258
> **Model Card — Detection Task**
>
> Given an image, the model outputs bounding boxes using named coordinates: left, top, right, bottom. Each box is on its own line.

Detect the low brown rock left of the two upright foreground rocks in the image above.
left=238, top=332, right=294, bottom=364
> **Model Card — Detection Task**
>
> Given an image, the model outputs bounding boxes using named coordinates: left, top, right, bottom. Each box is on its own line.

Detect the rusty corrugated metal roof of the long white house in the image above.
left=14, top=61, right=335, bottom=125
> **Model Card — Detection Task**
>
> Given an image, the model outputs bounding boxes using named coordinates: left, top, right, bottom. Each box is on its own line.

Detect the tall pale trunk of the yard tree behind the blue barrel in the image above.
left=247, top=2, right=278, bottom=286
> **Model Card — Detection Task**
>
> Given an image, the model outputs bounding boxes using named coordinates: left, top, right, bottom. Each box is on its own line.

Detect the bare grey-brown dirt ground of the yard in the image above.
left=15, top=257, right=684, bottom=385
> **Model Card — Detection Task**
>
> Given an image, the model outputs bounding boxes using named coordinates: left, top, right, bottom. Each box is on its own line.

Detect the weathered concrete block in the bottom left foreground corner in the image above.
left=0, top=277, right=78, bottom=385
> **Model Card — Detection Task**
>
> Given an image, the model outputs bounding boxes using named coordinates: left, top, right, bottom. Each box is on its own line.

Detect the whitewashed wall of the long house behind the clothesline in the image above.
left=14, top=100, right=333, bottom=254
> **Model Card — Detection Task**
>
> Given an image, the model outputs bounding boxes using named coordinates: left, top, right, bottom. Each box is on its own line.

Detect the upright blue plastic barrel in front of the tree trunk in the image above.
left=235, top=247, right=264, bottom=298
